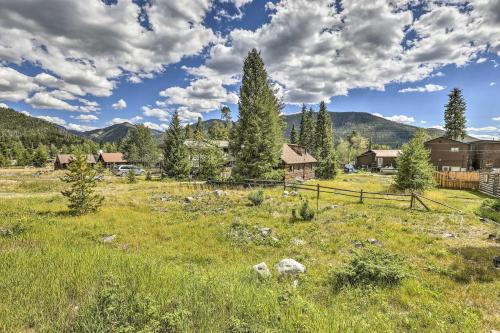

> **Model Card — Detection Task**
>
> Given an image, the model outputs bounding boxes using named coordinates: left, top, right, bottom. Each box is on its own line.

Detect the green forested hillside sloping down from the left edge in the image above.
left=0, top=108, right=83, bottom=148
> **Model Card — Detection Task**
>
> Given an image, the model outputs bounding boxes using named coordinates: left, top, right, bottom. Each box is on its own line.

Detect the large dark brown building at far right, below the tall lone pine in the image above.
left=425, top=137, right=500, bottom=171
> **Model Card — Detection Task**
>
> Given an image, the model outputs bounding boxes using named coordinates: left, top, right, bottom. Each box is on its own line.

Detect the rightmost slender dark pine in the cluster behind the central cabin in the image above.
left=315, top=102, right=338, bottom=179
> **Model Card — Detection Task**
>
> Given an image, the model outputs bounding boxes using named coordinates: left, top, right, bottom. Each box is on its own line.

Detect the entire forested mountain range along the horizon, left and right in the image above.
left=0, top=108, right=470, bottom=147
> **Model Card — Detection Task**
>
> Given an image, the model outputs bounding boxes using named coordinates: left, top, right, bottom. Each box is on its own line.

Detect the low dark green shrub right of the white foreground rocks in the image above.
left=332, top=249, right=408, bottom=289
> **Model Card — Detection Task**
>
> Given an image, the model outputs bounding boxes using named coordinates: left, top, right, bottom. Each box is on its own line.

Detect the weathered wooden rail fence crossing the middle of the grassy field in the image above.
left=207, top=179, right=461, bottom=212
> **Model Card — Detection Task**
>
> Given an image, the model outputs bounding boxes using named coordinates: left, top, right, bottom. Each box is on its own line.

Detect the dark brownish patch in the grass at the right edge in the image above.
left=450, top=246, right=500, bottom=283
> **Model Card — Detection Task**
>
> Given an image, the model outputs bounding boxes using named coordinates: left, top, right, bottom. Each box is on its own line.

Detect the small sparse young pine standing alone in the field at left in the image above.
left=62, top=151, right=104, bottom=215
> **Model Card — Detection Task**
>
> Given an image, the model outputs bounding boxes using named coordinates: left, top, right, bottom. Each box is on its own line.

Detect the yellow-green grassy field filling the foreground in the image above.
left=0, top=170, right=500, bottom=332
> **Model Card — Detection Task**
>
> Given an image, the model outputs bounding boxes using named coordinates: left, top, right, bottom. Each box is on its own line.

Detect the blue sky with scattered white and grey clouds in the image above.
left=0, top=0, right=500, bottom=137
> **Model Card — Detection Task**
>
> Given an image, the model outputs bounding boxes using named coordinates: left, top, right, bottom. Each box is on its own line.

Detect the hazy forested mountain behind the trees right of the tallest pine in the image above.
left=285, top=112, right=474, bottom=147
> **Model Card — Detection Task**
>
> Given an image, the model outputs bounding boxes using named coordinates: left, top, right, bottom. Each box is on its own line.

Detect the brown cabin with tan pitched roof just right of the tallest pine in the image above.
left=281, top=143, right=318, bottom=182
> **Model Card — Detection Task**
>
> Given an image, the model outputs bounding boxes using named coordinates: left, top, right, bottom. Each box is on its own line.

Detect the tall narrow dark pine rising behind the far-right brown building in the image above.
left=444, top=88, right=467, bottom=140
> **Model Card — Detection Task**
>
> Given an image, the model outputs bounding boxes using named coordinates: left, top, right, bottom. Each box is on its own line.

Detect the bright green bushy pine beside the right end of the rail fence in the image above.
left=396, top=130, right=435, bottom=191
